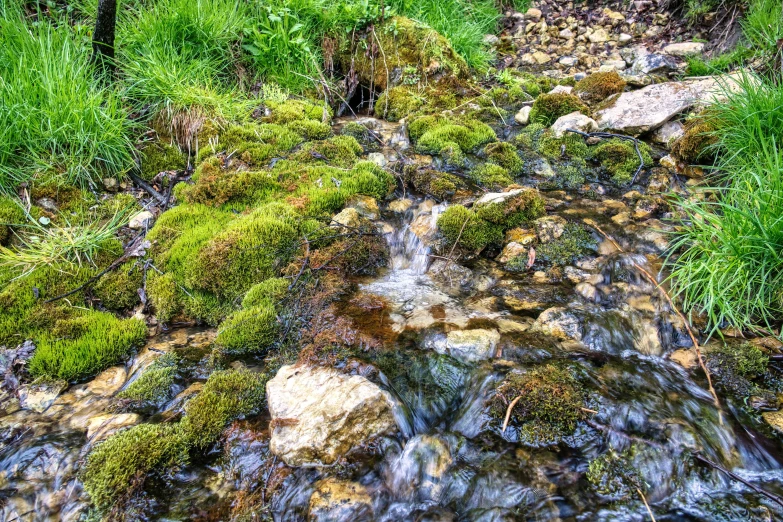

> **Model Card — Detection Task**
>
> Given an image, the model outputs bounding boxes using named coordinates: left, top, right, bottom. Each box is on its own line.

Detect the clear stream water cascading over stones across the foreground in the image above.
left=0, top=197, right=783, bottom=522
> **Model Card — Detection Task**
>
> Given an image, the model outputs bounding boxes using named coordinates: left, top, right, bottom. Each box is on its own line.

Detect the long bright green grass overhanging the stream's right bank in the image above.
left=669, top=72, right=783, bottom=332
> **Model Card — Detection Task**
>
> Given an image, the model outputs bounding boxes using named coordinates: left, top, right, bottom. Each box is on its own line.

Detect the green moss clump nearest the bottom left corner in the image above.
left=82, top=424, right=188, bottom=511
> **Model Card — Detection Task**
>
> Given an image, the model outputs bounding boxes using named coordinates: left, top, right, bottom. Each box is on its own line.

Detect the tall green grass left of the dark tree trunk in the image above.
left=0, top=9, right=133, bottom=193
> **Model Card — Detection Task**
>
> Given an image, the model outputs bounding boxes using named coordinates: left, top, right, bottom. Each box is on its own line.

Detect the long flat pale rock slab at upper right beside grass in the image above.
left=595, top=76, right=736, bottom=135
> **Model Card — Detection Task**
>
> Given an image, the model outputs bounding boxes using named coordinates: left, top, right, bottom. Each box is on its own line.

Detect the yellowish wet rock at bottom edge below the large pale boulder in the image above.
left=307, top=477, right=373, bottom=522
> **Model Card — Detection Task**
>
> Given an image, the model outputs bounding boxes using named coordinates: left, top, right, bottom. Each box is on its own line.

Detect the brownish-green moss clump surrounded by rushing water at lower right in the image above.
left=490, top=364, right=586, bottom=445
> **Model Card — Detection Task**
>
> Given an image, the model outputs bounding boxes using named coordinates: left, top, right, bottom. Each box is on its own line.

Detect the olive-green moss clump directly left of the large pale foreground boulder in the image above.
left=181, top=370, right=269, bottom=448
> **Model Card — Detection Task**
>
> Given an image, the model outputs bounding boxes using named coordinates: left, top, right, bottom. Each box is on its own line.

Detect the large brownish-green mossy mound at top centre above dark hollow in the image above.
left=338, top=16, right=468, bottom=90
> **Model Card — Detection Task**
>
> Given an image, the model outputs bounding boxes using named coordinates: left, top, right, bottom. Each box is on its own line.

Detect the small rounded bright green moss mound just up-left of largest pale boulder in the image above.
left=215, top=299, right=279, bottom=353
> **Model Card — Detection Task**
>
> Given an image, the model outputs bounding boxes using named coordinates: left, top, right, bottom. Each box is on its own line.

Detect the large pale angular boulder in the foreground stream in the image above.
left=266, top=365, right=396, bottom=466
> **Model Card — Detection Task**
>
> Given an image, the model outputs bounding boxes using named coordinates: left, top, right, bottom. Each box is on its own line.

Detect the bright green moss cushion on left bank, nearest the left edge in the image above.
left=28, top=311, right=147, bottom=381
